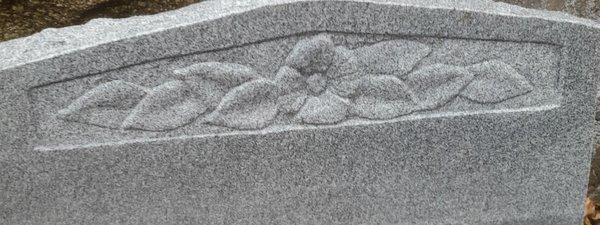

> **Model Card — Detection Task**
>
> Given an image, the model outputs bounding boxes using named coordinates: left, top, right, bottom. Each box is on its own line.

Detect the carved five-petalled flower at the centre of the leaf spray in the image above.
left=275, top=34, right=358, bottom=124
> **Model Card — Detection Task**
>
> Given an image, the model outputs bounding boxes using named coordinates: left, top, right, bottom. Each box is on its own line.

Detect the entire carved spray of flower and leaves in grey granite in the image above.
left=58, top=34, right=533, bottom=131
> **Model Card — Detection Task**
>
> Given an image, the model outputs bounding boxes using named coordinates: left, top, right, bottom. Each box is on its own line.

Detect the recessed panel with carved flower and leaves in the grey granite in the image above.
left=32, top=33, right=560, bottom=149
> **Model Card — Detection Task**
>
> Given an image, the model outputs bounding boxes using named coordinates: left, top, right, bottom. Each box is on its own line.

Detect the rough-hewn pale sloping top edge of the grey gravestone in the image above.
left=0, top=0, right=600, bottom=70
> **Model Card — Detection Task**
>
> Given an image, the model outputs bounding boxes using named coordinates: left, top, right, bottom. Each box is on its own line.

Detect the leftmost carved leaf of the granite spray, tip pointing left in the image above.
left=57, top=80, right=146, bottom=129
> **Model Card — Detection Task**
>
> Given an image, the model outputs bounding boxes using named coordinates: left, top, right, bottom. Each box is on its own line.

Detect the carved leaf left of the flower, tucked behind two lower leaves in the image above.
left=174, top=62, right=261, bottom=109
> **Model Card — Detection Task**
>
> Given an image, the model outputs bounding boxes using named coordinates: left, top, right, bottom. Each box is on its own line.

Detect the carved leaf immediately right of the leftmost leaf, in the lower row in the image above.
left=123, top=81, right=207, bottom=131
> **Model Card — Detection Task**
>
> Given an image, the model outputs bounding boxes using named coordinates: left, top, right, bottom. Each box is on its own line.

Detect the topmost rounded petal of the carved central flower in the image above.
left=285, top=34, right=334, bottom=75
